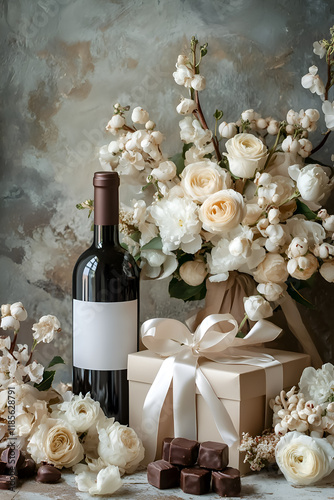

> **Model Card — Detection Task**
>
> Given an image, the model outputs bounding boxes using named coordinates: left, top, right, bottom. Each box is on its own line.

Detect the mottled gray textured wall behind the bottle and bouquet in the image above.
left=0, top=0, right=334, bottom=376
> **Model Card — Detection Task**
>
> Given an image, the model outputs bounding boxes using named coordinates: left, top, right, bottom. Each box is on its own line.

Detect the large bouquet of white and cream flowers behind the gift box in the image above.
left=78, top=28, right=334, bottom=366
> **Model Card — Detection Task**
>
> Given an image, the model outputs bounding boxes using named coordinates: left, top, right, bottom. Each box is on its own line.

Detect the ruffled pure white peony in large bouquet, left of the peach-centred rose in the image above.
left=150, top=198, right=202, bottom=254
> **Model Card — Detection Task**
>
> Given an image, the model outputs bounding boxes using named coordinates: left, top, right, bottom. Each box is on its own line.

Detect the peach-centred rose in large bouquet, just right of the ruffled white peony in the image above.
left=199, top=189, right=246, bottom=233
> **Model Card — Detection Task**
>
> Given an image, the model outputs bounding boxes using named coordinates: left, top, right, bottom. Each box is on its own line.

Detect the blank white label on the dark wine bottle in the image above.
left=73, top=299, right=138, bottom=371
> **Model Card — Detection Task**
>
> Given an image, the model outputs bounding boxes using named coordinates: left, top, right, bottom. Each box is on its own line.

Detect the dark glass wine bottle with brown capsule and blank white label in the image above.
left=72, top=172, right=139, bottom=424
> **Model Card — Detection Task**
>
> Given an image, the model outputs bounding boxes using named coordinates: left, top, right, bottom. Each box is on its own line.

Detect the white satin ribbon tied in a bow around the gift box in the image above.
left=141, top=314, right=282, bottom=461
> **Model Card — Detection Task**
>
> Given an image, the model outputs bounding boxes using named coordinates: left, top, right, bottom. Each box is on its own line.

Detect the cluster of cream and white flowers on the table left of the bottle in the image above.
left=0, top=302, right=144, bottom=495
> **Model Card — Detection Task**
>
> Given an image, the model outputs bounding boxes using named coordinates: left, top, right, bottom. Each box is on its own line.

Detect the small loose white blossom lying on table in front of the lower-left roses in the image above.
left=75, top=465, right=123, bottom=495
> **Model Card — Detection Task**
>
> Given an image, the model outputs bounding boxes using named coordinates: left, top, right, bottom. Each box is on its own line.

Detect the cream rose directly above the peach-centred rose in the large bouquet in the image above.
left=181, top=160, right=232, bottom=203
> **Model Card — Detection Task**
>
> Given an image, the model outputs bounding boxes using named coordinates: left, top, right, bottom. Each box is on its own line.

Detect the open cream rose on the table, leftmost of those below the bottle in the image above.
left=27, top=417, right=84, bottom=468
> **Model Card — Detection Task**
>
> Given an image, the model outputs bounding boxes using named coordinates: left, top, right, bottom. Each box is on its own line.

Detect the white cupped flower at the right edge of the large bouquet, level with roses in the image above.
left=289, top=165, right=331, bottom=202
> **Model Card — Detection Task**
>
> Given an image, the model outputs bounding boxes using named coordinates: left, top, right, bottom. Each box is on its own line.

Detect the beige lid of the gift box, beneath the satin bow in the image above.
left=128, top=347, right=311, bottom=401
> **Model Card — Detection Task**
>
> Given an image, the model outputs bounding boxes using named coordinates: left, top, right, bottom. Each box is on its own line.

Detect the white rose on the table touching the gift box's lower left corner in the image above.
left=98, top=419, right=145, bottom=474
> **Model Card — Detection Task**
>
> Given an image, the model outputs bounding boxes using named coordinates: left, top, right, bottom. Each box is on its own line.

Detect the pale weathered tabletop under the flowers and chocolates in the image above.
left=0, top=471, right=334, bottom=500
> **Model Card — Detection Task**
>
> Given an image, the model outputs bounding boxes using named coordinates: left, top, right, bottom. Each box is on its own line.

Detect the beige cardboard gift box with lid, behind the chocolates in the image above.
left=128, top=347, right=310, bottom=474
